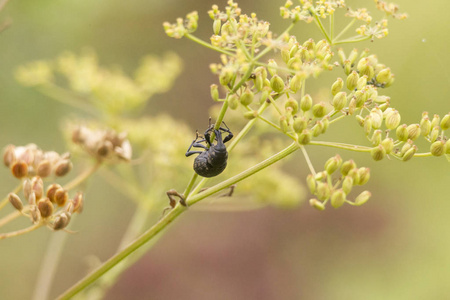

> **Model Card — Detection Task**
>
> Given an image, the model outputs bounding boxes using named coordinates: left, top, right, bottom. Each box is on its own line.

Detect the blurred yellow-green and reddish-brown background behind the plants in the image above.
left=0, top=0, right=450, bottom=299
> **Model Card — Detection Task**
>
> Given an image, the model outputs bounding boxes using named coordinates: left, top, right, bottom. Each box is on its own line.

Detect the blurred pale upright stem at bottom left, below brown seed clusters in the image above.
left=33, top=232, right=69, bottom=300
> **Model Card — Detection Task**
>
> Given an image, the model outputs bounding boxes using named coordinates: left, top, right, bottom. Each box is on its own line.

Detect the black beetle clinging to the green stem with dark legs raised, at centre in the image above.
left=186, top=119, right=233, bottom=177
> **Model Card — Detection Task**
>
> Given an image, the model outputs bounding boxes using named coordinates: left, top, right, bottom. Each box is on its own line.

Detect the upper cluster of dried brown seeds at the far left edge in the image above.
left=3, top=144, right=72, bottom=178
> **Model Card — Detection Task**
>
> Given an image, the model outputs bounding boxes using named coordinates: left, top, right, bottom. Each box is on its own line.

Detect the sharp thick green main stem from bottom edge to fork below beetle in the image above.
left=58, top=204, right=187, bottom=299
